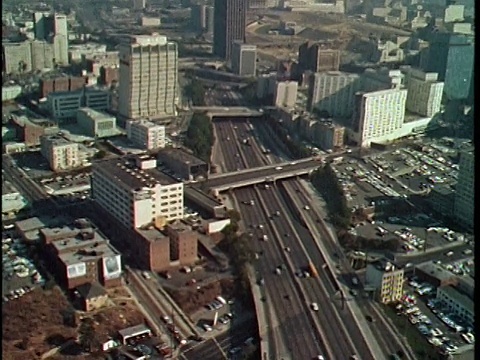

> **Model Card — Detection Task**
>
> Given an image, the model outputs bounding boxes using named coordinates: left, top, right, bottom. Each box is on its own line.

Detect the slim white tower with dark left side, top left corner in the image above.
left=33, top=12, right=68, bottom=65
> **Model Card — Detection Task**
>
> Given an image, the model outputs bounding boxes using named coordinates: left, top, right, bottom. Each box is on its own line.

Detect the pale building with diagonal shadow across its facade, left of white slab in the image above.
left=307, top=71, right=362, bottom=118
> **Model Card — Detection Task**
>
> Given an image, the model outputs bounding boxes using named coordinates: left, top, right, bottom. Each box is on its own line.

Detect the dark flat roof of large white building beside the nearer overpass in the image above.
left=93, top=155, right=179, bottom=190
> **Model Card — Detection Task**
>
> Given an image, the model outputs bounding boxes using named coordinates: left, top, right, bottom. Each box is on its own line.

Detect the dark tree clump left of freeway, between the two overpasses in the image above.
left=185, top=113, right=214, bottom=162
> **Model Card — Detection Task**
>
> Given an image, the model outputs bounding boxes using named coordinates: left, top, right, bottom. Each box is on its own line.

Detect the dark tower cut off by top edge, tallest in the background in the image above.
left=213, top=0, right=247, bottom=60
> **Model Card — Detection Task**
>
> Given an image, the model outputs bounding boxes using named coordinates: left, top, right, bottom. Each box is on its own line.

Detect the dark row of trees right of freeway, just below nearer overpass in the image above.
left=312, top=164, right=352, bottom=229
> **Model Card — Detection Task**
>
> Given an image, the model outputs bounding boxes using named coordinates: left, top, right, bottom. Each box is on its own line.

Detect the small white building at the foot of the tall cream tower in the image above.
left=126, top=119, right=165, bottom=150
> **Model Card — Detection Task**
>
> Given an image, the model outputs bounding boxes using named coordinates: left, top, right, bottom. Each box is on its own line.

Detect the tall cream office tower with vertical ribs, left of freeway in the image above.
left=118, top=34, right=178, bottom=119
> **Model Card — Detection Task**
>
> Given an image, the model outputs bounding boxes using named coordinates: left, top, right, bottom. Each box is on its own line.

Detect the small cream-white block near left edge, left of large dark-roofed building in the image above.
left=40, top=135, right=81, bottom=171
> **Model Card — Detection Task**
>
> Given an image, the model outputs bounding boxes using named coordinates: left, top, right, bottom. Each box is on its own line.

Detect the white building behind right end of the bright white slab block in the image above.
left=405, top=69, right=444, bottom=117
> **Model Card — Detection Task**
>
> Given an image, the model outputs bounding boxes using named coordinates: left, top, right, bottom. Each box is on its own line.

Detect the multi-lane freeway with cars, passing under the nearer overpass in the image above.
left=214, top=120, right=412, bottom=359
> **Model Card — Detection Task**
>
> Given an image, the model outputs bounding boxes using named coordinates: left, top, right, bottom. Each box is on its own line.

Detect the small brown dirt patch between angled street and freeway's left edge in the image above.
left=166, top=279, right=235, bottom=315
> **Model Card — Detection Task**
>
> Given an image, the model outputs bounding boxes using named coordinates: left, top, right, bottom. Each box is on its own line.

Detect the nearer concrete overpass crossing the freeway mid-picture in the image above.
left=197, top=158, right=323, bottom=195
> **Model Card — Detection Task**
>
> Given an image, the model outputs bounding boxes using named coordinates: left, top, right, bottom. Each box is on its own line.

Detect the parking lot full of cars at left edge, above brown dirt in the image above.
left=2, top=230, right=45, bottom=302
